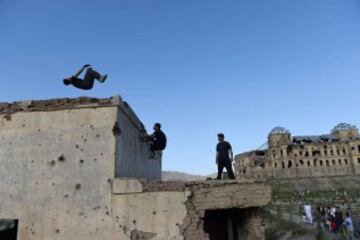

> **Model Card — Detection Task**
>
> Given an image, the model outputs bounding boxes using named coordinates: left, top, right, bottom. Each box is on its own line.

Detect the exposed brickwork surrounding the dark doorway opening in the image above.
left=181, top=181, right=271, bottom=240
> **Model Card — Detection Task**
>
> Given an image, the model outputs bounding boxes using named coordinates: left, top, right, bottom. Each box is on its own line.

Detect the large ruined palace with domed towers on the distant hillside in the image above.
left=235, top=123, right=360, bottom=179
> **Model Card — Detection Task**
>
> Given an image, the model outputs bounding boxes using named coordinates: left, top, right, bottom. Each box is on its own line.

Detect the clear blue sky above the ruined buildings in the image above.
left=0, top=0, right=360, bottom=174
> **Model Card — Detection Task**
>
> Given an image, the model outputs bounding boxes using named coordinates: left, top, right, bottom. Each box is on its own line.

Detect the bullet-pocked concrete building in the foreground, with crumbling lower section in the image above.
left=0, top=97, right=271, bottom=240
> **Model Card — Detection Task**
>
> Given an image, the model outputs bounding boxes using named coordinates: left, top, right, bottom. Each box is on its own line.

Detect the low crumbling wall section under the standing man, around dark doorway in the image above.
left=113, top=179, right=271, bottom=240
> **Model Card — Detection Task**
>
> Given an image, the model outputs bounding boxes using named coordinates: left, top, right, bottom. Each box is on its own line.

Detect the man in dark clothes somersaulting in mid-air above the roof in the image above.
left=64, top=64, right=107, bottom=90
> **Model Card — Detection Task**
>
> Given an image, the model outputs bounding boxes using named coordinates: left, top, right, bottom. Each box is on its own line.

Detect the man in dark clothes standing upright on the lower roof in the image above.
left=216, top=133, right=235, bottom=179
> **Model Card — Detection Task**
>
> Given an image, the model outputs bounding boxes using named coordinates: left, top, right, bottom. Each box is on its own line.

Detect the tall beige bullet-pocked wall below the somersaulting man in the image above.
left=0, top=98, right=161, bottom=240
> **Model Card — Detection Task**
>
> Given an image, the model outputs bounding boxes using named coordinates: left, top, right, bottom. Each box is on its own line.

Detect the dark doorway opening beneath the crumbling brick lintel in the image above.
left=204, top=208, right=248, bottom=240
